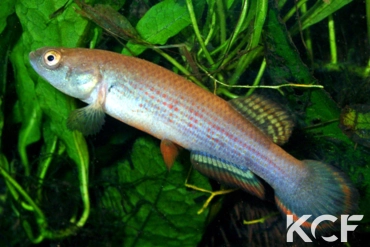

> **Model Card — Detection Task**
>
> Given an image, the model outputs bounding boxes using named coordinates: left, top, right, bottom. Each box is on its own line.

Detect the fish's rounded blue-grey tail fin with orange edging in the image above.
left=275, top=160, right=358, bottom=231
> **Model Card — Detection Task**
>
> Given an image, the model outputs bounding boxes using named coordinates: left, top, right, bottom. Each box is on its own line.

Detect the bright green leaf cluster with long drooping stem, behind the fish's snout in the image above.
left=12, top=0, right=90, bottom=236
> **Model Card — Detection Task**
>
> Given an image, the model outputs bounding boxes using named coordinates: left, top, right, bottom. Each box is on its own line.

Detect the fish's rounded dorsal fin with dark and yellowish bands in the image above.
left=229, top=94, right=294, bottom=145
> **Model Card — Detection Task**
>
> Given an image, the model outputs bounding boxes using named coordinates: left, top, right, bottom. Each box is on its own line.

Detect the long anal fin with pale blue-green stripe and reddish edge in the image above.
left=190, top=151, right=265, bottom=199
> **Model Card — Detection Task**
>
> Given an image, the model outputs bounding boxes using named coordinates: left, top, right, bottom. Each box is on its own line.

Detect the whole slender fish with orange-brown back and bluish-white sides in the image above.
left=29, top=47, right=358, bottom=232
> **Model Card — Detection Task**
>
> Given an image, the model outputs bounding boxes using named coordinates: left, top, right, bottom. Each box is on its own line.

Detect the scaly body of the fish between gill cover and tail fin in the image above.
left=86, top=50, right=300, bottom=187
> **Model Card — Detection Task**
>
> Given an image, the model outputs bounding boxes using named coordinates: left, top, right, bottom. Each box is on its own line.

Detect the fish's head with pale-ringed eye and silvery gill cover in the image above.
left=29, top=47, right=101, bottom=100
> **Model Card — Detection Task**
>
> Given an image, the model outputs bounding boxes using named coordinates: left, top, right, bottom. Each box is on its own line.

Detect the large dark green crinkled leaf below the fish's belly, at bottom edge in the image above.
left=99, top=137, right=210, bottom=246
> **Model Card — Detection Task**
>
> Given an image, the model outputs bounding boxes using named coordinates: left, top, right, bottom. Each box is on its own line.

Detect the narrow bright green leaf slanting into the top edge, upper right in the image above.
left=291, top=0, right=352, bottom=35
